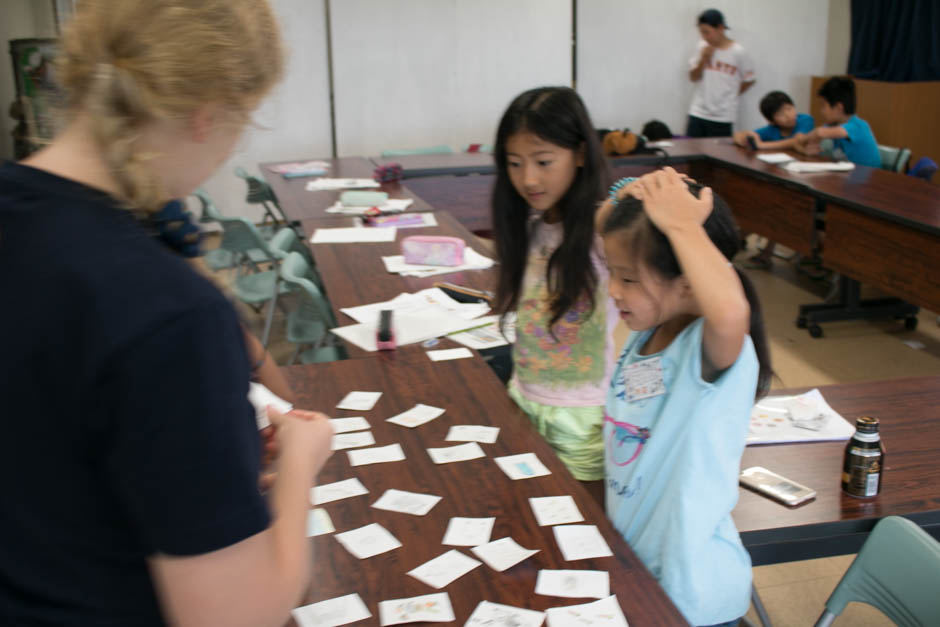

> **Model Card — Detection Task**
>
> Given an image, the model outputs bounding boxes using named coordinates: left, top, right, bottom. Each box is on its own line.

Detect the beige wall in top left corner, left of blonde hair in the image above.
left=0, top=0, right=56, bottom=159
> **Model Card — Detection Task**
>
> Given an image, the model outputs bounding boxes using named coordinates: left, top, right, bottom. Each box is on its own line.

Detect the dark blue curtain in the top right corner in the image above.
left=848, top=0, right=940, bottom=83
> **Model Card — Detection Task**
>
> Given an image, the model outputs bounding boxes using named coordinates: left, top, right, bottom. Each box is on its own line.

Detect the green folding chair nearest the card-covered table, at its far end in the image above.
left=281, top=252, right=346, bottom=365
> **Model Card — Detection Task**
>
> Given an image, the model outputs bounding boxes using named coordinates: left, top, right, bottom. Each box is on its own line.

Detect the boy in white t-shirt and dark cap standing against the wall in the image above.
left=686, top=9, right=755, bottom=137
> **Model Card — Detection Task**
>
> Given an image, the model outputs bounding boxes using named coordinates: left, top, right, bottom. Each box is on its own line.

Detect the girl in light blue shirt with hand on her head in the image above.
left=599, top=168, right=771, bottom=625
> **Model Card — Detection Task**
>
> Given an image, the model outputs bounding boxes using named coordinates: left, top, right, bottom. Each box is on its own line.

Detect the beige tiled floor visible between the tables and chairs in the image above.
left=229, top=237, right=940, bottom=627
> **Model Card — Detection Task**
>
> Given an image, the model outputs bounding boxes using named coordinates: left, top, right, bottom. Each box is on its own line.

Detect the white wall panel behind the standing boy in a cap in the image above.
left=577, top=0, right=829, bottom=134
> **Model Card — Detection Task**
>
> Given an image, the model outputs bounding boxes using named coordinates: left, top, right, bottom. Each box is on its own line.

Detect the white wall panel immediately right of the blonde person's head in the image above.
left=196, top=0, right=332, bottom=220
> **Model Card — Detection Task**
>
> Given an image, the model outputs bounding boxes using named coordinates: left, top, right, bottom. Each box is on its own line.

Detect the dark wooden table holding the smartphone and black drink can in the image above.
left=733, top=376, right=940, bottom=565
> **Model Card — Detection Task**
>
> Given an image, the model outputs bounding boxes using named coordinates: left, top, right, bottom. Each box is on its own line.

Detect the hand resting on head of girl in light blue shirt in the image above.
left=630, top=167, right=712, bottom=233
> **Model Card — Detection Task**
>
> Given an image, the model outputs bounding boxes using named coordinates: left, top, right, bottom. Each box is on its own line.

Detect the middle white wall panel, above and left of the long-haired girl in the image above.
left=330, top=0, right=571, bottom=156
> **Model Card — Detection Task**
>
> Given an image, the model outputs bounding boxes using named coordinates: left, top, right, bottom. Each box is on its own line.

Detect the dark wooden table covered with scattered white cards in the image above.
left=285, top=353, right=686, bottom=625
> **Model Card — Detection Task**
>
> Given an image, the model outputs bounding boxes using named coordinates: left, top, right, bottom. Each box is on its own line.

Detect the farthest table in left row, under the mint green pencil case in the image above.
left=260, top=157, right=431, bottom=220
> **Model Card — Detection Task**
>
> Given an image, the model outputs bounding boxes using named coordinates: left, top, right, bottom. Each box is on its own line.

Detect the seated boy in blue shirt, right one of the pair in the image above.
left=796, top=76, right=881, bottom=168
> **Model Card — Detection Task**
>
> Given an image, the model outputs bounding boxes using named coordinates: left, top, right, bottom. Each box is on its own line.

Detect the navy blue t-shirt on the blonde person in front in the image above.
left=0, top=163, right=270, bottom=625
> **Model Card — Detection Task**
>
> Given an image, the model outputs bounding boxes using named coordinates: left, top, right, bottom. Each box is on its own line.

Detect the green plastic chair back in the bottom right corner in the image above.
left=816, top=516, right=940, bottom=627
